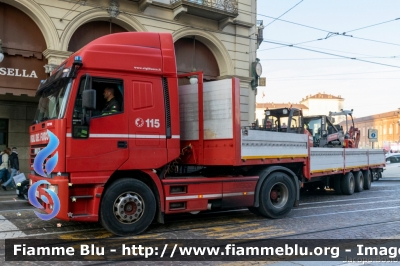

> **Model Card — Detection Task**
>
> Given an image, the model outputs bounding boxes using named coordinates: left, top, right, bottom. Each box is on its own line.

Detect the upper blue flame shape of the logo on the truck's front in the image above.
left=33, top=130, right=60, bottom=177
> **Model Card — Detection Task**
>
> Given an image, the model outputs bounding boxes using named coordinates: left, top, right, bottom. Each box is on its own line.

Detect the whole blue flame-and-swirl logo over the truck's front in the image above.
left=28, top=130, right=60, bottom=221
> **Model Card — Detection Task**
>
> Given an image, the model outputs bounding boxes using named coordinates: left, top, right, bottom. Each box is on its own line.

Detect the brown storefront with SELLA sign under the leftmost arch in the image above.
left=0, top=3, right=48, bottom=172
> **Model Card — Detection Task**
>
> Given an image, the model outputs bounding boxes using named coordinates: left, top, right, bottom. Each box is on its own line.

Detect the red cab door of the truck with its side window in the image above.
left=66, top=76, right=129, bottom=183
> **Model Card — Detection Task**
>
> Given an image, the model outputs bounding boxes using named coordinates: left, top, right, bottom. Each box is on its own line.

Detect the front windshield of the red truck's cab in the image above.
left=34, top=78, right=72, bottom=123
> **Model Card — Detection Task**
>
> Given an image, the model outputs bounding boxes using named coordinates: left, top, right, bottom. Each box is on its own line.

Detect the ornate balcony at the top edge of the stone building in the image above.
left=171, top=0, right=239, bottom=20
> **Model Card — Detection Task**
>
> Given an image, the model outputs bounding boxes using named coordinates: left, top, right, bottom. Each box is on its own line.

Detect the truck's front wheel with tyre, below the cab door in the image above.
left=100, top=178, right=156, bottom=236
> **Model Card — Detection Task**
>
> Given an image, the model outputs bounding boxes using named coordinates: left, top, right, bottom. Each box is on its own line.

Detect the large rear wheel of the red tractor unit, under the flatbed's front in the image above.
left=258, top=172, right=296, bottom=219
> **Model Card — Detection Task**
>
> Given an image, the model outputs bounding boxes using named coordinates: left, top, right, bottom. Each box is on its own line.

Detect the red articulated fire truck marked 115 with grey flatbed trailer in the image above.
left=29, top=32, right=385, bottom=235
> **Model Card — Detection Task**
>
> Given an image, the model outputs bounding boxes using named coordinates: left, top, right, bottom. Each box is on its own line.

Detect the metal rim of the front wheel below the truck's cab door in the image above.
left=114, top=192, right=144, bottom=224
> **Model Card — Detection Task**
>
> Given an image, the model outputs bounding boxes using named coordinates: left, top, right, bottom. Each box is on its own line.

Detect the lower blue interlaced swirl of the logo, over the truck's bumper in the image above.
left=28, top=180, right=60, bottom=221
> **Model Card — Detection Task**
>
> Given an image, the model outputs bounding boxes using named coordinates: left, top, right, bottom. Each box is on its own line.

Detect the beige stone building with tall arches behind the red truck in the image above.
left=0, top=0, right=262, bottom=172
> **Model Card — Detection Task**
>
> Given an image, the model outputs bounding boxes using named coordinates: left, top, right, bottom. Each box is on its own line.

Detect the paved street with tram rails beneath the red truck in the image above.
left=0, top=178, right=400, bottom=265
